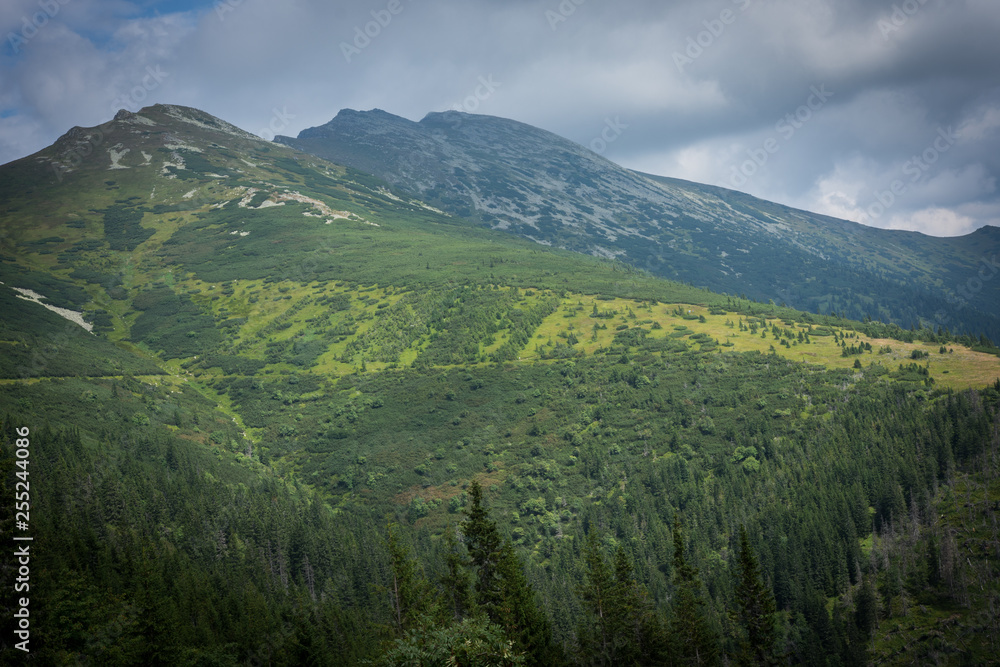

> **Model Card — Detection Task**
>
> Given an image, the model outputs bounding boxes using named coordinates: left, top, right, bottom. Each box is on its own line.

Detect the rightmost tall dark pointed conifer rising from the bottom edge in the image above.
left=733, top=526, right=778, bottom=665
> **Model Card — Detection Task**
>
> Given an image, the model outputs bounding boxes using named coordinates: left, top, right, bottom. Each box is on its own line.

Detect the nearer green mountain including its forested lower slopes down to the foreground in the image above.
left=0, top=105, right=1000, bottom=665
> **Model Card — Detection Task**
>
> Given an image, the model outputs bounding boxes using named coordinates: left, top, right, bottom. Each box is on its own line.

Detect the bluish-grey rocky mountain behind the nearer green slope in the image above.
left=276, top=109, right=1000, bottom=338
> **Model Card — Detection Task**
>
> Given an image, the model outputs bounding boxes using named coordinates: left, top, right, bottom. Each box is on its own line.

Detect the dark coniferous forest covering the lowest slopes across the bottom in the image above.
left=3, top=357, right=1000, bottom=665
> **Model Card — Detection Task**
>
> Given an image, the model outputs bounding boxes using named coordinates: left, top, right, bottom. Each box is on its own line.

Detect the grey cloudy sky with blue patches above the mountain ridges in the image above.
left=0, top=0, right=1000, bottom=236
